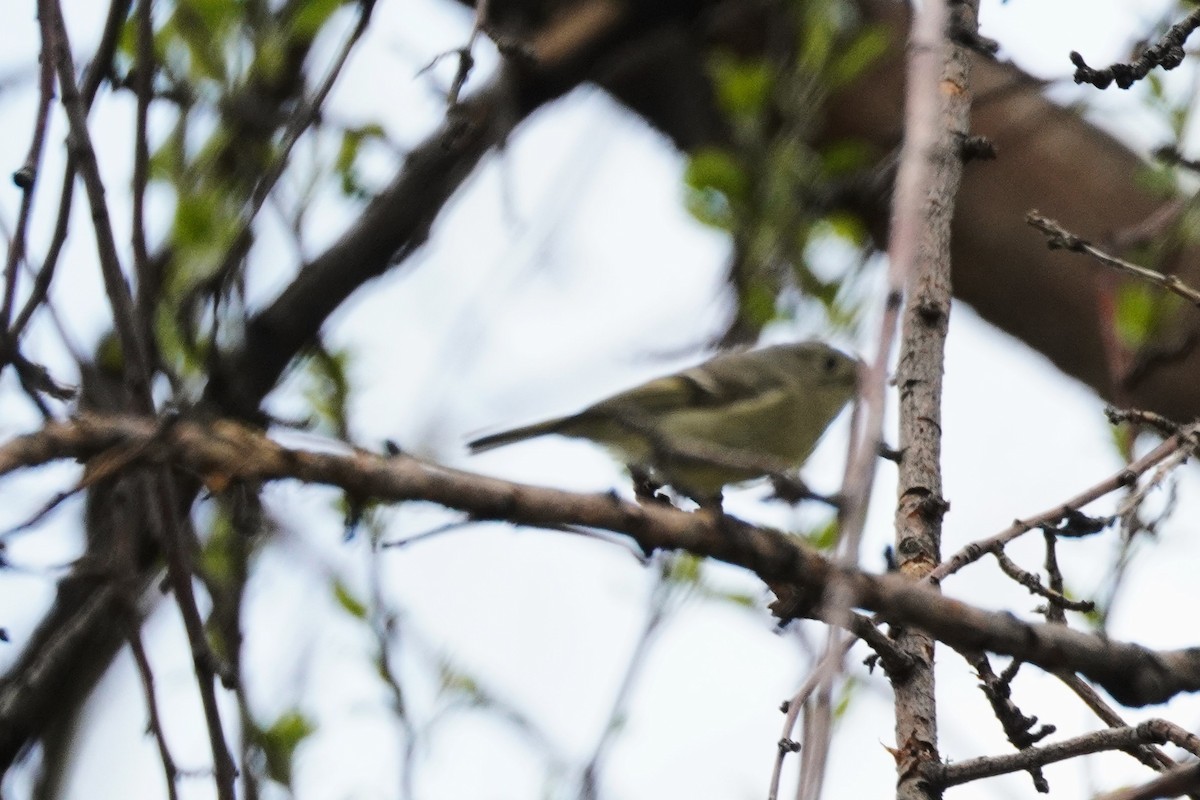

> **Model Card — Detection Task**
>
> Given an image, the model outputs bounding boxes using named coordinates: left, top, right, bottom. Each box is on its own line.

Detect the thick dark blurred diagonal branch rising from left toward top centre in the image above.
left=206, top=0, right=665, bottom=417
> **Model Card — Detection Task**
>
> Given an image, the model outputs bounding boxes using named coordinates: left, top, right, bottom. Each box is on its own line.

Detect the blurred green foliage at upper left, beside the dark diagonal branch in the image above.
left=116, top=0, right=384, bottom=389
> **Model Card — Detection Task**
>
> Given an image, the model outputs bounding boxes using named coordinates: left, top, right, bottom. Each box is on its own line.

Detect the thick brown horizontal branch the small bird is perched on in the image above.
left=0, top=416, right=1200, bottom=705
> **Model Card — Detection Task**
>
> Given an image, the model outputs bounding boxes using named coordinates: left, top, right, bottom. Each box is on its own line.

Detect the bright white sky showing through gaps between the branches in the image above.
left=0, top=0, right=1200, bottom=800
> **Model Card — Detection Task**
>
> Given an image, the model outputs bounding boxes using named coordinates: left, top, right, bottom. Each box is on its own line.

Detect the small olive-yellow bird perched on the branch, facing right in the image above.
left=469, top=342, right=859, bottom=505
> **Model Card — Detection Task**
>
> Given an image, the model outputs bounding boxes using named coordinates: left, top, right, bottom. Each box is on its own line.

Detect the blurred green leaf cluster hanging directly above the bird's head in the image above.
left=684, top=0, right=888, bottom=329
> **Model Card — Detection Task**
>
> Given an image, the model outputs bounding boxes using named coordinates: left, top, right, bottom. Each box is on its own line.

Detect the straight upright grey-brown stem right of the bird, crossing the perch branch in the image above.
left=888, top=0, right=977, bottom=800
